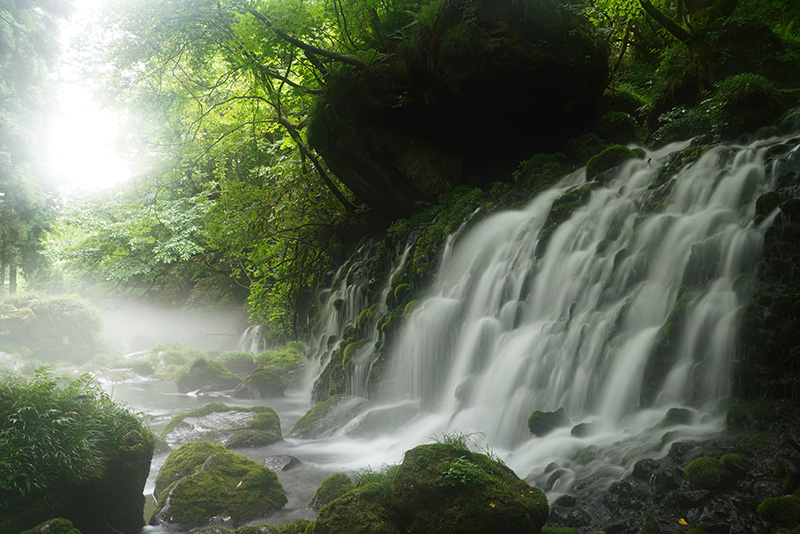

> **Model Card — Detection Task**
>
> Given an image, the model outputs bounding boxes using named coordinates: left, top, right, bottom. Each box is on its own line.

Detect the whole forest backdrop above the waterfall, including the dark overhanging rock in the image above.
left=0, top=0, right=800, bottom=339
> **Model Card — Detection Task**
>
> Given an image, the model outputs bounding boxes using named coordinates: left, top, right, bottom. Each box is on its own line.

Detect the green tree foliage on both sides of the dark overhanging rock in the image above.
left=10, top=0, right=800, bottom=337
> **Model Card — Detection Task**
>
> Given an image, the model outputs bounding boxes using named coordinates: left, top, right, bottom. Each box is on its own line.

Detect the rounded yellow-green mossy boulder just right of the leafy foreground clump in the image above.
left=150, top=443, right=287, bottom=530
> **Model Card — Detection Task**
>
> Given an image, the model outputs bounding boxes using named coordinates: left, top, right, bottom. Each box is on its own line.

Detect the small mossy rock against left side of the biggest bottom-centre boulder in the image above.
left=310, top=482, right=400, bottom=534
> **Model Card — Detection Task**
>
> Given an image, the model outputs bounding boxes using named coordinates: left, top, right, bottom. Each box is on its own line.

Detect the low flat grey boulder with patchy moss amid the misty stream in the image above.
left=161, top=402, right=283, bottom=448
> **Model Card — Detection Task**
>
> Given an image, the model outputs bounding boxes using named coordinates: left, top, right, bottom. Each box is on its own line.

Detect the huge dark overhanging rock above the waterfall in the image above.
left=309, top=0, right=608, bottom=218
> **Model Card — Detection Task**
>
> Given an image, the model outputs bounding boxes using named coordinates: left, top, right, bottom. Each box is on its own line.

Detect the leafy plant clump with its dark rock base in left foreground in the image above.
left=0, top=370, right=153, bottom=532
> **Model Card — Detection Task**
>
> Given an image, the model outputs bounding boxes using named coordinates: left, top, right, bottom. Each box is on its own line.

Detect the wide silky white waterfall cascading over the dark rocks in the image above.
left=301, top=135, right=792, bottom=501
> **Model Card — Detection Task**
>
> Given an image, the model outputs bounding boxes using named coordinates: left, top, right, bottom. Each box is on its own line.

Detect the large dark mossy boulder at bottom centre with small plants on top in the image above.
left=391, top=443, right=549, bottom=534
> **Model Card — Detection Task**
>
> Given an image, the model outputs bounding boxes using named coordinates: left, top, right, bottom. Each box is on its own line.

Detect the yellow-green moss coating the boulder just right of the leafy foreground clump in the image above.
left=154, top=444, right=287, bottom=529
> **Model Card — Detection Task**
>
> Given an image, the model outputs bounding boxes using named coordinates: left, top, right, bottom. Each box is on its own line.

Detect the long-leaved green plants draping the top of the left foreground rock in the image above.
left=0, top=368, right=152, bottom=508
